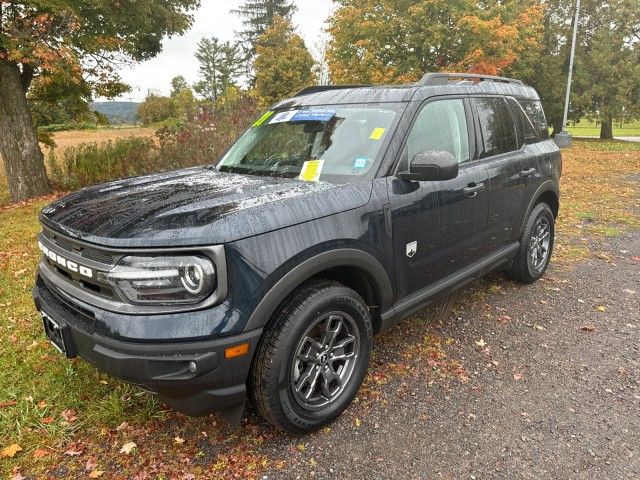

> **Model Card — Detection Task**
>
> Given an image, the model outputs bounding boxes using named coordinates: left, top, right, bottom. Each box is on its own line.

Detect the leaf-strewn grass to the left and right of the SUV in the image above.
left=0, top=138, right=640, bottom=478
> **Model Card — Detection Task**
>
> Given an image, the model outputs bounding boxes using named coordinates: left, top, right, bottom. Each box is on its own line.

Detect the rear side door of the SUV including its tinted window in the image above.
left=472, top=97, right=535, bottom=251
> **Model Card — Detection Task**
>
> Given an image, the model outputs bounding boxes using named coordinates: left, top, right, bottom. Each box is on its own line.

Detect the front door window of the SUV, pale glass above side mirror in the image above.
left=403, top=98, right=469, bottom=163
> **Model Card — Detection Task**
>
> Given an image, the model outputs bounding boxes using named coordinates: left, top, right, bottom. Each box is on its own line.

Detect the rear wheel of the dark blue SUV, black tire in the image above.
left=509, top=203, right=555, bottom=283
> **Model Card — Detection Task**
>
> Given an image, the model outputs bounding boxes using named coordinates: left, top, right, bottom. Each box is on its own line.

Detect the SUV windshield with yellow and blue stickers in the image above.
left=218, top=105, right=396, bottom=183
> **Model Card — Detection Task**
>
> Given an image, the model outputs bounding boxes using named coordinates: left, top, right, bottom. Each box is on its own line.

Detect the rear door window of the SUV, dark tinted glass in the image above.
left=474, top=97, right=518, bottom=158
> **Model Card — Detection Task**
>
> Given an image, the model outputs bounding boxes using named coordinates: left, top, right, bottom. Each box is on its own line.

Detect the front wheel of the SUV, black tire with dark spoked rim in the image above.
left=249, top=281, right=373, bottom=433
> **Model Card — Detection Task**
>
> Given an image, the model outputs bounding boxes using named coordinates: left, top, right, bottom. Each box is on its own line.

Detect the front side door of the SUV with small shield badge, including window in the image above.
left=387, top=98, right=489, bottom=298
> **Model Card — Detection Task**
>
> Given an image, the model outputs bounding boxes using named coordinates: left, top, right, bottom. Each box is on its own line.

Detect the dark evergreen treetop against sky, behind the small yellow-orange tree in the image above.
left=232, top=0, right=296, bottom=54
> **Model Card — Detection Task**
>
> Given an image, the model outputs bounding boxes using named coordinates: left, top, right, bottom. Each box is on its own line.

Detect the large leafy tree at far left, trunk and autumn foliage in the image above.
left=0, top=0, right=199, bottom=201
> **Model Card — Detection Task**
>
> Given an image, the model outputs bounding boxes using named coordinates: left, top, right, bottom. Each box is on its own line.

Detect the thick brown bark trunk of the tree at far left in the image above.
left=0, top=60, right=51, bottom=202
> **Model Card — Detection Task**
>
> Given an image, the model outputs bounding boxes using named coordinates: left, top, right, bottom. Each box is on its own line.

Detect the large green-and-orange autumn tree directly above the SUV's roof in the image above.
left=327, top=0, right=543, bottom=83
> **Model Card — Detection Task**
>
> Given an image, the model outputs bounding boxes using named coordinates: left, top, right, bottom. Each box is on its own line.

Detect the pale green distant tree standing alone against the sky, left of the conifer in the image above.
left=195, top=37, right=244, bottom=102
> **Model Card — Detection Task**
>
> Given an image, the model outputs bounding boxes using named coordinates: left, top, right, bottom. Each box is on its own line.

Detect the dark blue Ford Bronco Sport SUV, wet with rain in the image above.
left=33, top=73, right=561, bottom=432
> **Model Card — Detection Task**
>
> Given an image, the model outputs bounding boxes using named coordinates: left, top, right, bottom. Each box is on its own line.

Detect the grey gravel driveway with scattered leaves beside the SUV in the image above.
left=253, top=231, right=640, bottom=479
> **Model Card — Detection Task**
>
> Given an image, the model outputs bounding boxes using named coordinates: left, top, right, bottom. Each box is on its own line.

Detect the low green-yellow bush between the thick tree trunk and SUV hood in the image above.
left=49, top=137, right=164, bottom=190
